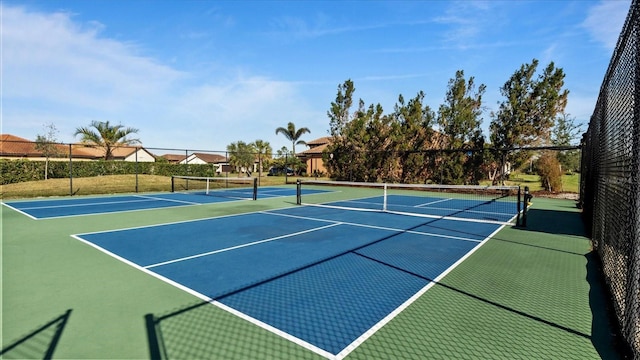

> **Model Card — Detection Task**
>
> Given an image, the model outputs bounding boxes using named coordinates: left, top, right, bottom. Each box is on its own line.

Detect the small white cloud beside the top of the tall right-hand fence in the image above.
left=582, top=0, right=630, bottom=49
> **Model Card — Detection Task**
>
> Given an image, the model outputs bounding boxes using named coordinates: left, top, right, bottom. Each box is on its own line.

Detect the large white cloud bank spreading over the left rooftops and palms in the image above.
left=0, top=5, right=324, bottom=150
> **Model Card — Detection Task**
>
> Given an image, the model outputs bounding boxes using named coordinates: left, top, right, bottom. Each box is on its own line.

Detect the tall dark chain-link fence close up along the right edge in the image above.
left=580, top=0, right=640, bottom=359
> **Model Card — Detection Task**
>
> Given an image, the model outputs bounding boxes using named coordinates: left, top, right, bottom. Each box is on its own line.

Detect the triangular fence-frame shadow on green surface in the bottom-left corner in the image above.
left=0, top=309, right=71, bottom=359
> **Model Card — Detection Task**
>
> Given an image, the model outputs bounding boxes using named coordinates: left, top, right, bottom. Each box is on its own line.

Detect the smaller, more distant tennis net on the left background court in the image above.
left=171, top=176, right=258, bottom=200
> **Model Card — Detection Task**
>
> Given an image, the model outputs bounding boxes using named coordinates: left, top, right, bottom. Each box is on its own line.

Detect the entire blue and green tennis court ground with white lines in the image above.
left=2, top=184, right=613, bottom=359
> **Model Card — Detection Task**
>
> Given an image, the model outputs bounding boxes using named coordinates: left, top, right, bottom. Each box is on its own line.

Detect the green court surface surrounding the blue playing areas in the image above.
left=1, top=190, right=620, bottom=359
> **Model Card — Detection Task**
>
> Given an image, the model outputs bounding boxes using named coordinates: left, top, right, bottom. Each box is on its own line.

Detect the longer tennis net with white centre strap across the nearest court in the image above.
left=297, top=180, right=526, bottom=226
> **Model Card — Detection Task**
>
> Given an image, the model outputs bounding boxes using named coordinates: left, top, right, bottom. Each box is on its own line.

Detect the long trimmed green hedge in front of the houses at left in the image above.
left=0, top=159, right=220, bottom=185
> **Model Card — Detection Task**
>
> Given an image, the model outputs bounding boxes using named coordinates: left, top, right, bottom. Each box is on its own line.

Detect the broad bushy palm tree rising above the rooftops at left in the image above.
left=74, top=120, right=140, bottom=160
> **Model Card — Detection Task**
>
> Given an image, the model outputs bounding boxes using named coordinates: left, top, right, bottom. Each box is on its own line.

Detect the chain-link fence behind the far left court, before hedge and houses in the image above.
left=0, top=138, right=304, bottom=198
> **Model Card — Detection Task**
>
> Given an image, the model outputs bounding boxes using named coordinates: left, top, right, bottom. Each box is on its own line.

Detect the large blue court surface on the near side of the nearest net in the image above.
left=74, top=202, right=508, bottom=357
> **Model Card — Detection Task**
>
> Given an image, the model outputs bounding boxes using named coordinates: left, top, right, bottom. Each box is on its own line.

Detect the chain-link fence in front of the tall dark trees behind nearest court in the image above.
left=325, top=145, right=580, bottom=193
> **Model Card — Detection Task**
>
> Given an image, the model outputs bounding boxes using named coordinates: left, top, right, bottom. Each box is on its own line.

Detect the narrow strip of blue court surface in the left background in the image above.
left=4, top=187, right=321, bottom=219
